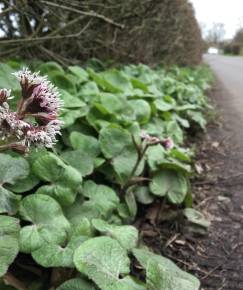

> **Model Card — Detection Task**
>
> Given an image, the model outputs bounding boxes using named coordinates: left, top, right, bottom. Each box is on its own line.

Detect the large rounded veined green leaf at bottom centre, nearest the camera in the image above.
left=74, top=237, right=130, bottom=290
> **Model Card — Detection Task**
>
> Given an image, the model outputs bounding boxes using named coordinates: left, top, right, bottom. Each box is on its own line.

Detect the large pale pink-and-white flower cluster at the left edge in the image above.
left=0, top=68, right=62, bottom=152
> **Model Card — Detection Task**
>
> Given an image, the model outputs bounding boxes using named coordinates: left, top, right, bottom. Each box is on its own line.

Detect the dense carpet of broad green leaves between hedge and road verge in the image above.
left=0, top=60, right=212, bottom=290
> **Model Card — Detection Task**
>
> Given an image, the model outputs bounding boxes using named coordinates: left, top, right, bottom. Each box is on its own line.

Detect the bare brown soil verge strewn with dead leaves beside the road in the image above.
left=140, top=81, right=243, bottom=290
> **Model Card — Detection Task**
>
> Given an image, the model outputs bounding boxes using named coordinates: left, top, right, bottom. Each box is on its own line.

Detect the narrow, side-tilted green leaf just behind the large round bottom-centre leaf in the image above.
left=92, top=219, right=138, bottom=250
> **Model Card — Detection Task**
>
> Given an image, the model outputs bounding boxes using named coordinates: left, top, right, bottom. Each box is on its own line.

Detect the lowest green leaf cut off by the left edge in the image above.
left=0, top=215, right=20, bottom=277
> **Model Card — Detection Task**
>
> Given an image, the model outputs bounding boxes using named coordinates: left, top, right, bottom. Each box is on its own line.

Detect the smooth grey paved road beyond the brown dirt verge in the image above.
left=204, top=55, right=243, bottom=121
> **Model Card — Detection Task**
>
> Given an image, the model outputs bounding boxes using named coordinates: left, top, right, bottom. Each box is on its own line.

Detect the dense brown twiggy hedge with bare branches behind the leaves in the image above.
left=0, top=0, right=202, bottom=65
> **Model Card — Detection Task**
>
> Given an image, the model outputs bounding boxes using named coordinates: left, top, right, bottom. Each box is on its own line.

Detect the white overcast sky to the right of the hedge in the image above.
left=190, top=0, right=243, bottom=39
